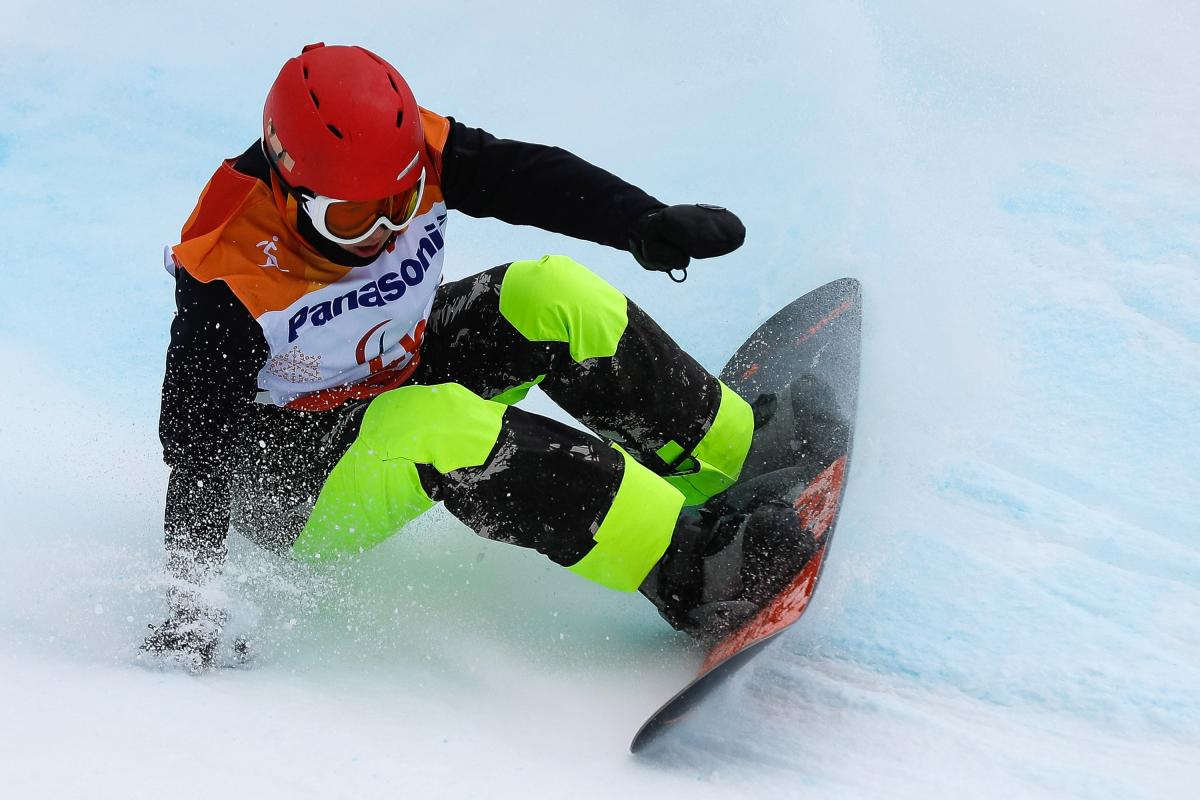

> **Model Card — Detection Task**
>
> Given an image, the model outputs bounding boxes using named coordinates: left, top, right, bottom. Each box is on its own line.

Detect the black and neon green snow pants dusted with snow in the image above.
left=292, top=255, right=754, bottom=591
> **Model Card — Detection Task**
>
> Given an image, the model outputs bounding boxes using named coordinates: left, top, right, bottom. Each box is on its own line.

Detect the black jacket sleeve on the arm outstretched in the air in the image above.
left=442, top=119, right=665, bottom=249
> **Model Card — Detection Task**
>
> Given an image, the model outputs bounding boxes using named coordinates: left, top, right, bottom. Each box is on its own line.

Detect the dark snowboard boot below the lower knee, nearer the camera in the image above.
left=640, top=501, right=817, bottom=645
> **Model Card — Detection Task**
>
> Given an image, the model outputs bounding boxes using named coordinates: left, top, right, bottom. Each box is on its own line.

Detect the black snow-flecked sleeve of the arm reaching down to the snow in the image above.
left=158, top=269, right=268, bottom=581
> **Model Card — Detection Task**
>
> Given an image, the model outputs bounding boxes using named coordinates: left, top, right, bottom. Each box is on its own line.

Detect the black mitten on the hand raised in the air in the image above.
left=629, top=204, right=746, bottom=281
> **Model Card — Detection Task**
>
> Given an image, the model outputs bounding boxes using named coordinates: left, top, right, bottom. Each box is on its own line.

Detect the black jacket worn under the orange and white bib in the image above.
left=158, top=119, right=664, bottom=579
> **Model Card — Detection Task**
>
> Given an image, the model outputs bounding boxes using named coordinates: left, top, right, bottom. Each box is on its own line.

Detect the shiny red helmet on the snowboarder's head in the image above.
left=263, top=43, right=425, bottom=200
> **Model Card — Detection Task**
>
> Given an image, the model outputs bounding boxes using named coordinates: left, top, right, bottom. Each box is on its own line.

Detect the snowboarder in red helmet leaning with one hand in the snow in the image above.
left=143, top=44, right=812, bottom=668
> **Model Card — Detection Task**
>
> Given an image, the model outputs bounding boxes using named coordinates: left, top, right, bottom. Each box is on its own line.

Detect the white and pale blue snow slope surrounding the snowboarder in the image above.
left=0, top=0, right=1200, bottom=798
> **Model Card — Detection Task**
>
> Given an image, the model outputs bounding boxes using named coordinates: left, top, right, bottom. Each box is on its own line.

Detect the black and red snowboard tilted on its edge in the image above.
left=630, top=278, right=862, bottom=753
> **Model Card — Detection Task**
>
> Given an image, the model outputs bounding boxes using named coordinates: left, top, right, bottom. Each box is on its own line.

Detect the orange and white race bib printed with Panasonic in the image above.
left=168, top=109, right=449, bottom=410
